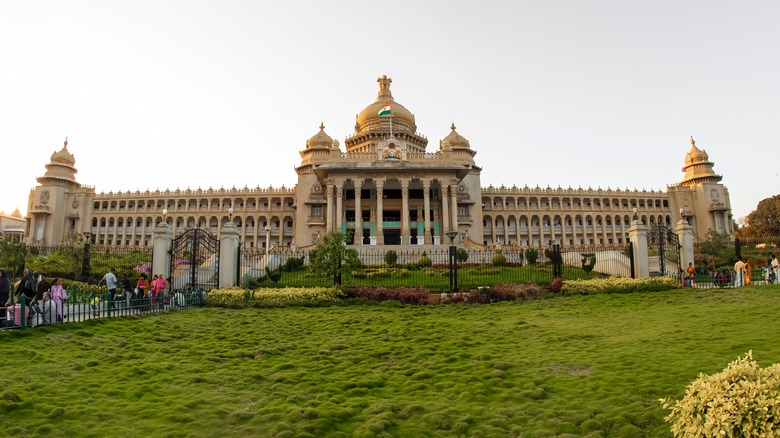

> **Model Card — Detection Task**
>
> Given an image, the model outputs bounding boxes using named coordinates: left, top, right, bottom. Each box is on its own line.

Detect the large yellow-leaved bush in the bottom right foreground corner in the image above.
left=659, top=351, right=780, bottom=437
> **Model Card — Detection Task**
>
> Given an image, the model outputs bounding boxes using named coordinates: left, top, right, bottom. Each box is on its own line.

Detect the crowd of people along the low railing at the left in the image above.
left=0, top=268, right=168, bottom=328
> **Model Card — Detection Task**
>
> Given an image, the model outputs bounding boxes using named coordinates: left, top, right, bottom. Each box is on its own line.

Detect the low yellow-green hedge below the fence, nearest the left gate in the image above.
left=206, top=287, right=344, bottom=308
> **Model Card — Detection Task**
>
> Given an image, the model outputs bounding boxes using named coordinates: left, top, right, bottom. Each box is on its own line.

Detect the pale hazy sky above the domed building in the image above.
left=0, top=0, right=780, bottom=222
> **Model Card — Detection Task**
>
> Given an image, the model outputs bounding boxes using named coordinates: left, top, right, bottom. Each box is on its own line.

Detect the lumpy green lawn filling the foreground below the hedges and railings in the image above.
left=0, top=286, right=780, bottom=437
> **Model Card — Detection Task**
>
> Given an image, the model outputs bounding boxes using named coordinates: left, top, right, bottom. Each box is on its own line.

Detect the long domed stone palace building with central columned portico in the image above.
left=25, top=76, right=733, bottom=250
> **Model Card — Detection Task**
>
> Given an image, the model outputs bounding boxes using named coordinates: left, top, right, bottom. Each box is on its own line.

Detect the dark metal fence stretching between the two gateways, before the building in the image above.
left=238, top=245, right=631, bottom=292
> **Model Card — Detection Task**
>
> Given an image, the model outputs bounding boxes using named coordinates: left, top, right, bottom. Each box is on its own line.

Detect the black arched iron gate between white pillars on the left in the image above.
left=169, top=228, right=219, bottom=305
